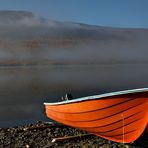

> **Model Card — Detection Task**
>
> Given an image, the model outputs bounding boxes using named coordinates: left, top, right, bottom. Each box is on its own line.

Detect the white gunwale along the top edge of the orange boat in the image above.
left=44, top=88, right=148, bottom=105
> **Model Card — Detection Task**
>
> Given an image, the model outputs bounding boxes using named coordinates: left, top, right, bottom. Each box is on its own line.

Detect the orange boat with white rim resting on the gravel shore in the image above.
left=44, top=88, right=148, bottom=143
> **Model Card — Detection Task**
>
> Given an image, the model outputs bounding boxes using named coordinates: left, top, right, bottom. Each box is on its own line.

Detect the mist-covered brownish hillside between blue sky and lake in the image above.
left=0, top=11, right=148, bottom=66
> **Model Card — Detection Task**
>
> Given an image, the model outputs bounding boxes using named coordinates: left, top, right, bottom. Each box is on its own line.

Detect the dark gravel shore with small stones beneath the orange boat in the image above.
left=0, top=122, right=148, bottom=148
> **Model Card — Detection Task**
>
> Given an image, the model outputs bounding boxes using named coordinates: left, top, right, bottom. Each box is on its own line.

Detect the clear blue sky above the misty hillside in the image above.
left=0, top=0, right=148, bottom=28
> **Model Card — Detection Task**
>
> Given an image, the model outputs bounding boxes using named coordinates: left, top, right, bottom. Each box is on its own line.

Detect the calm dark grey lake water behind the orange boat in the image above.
left=0, top=64, right=148, bottom=127
